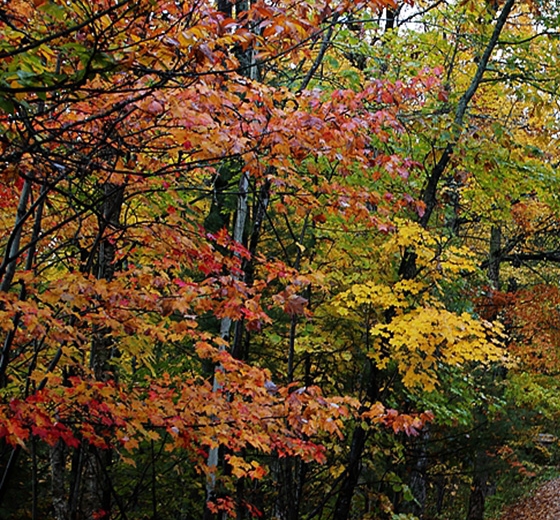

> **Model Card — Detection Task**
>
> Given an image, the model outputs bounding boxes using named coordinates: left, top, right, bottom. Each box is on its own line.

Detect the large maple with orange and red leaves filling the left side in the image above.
left=0, top=0, right=442, bottom=519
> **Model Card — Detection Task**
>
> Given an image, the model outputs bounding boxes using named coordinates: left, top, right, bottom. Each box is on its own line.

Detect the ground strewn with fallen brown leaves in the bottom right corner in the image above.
left=500, top=478, right=560, bottom=520
